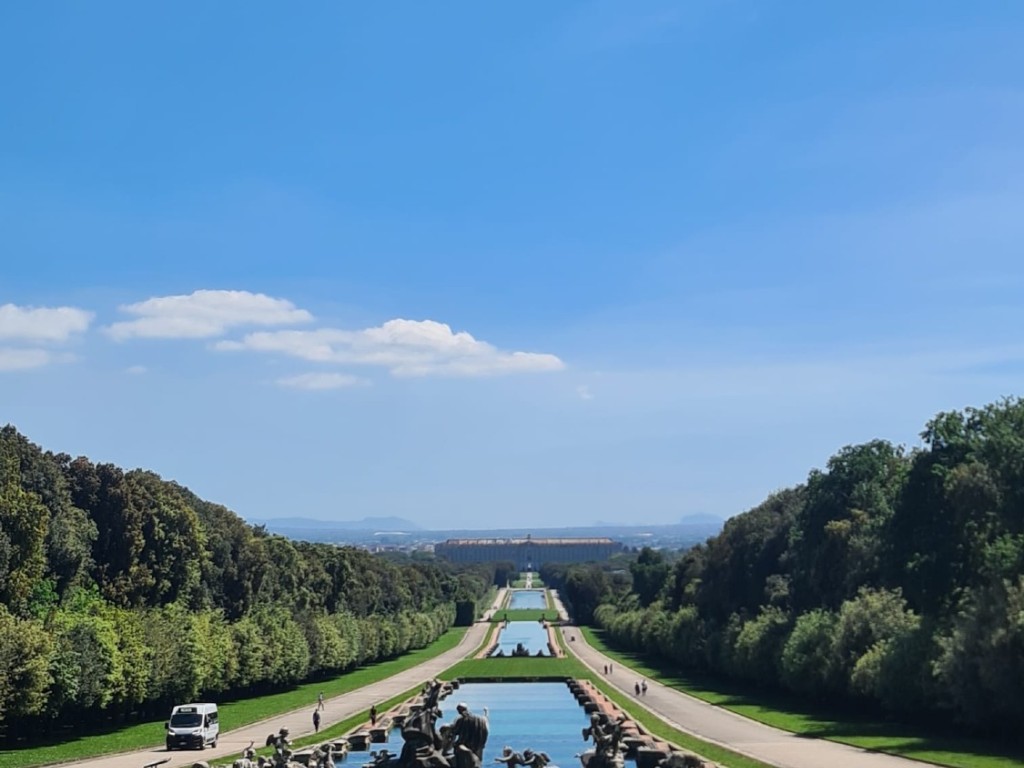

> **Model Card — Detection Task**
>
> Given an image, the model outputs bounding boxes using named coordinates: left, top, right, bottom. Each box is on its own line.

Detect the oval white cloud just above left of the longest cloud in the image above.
left=106, top=291, right=312, bottom=341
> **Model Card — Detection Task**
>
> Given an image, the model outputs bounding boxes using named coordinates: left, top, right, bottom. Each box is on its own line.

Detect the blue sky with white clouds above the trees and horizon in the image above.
left=0, top=0, right=1024, bottom=528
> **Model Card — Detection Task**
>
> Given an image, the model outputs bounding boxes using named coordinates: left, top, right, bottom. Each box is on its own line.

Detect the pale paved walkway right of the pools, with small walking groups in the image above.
left=562, top=627, right=926, bottom=768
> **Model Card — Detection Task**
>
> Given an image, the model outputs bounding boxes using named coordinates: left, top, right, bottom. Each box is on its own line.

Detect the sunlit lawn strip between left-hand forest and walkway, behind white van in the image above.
left=0, top=627, right=466, bottom=768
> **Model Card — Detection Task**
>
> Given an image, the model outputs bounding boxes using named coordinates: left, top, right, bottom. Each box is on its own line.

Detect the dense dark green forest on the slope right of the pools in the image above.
left=542, top=399, right=1024, bottom=739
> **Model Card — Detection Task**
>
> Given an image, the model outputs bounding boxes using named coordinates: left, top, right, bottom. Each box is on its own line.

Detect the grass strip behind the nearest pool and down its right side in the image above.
left=442, top=656, right=771, bottom=768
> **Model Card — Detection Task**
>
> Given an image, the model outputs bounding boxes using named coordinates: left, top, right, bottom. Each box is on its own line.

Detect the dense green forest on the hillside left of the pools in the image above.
left=0, top=426, right=495, bottom=735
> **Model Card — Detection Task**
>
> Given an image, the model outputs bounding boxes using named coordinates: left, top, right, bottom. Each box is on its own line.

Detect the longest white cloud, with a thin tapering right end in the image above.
left=216, top=319, right=565, bottom=376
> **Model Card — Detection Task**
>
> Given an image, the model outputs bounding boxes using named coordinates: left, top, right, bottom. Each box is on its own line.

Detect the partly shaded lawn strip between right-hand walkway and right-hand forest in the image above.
left=581, top=627, right=1024, bottom=768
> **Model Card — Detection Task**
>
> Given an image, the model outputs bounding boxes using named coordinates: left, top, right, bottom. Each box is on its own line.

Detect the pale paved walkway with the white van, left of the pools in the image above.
left=62, top=590, right=505, bottom=768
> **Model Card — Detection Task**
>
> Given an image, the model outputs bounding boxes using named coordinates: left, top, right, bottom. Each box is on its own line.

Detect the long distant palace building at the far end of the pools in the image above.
left=434, top=536, right=623, bottom=570
